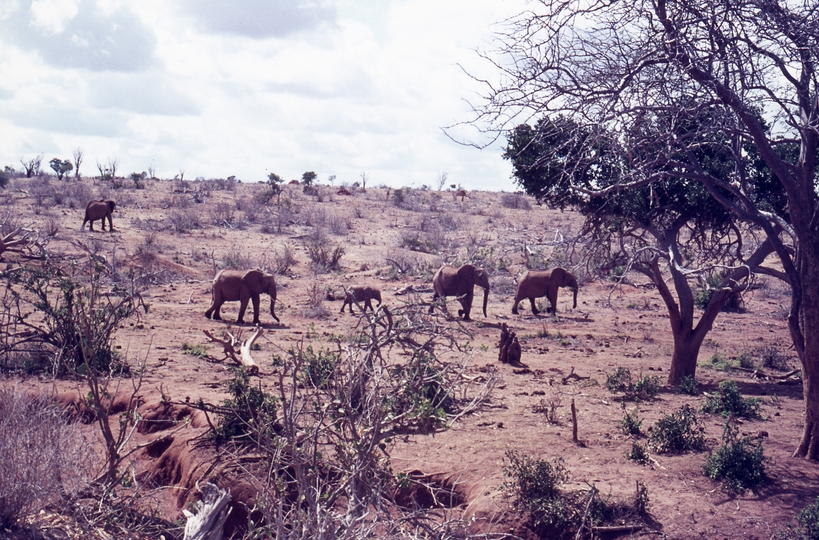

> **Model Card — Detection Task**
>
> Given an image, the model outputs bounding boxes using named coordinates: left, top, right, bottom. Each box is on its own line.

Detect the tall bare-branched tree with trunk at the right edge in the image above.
left=474, top=0, right=819, bottom=459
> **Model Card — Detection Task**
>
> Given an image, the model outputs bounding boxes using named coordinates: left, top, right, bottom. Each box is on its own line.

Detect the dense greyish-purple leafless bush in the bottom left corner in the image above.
left=0, top=387, right=94, bottom=528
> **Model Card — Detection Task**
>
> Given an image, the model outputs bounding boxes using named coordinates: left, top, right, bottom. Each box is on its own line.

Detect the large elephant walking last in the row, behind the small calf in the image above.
left=205, top=270, right=279, bottom=324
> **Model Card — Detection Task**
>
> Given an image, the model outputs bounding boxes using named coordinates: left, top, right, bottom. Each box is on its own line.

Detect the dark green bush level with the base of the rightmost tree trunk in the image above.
left=702, top=422, right=765, bottom=492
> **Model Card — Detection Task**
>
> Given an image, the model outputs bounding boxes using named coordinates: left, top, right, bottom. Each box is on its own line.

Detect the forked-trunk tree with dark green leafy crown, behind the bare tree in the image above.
left=503, top=117, right=773, bottom=385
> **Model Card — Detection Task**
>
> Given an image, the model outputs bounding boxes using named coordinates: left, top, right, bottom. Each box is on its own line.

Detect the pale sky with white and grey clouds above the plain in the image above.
left=0, top=0, right=526, bottom=190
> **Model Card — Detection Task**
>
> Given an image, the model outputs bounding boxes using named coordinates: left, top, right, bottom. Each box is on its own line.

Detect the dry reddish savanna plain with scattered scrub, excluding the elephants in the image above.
left=0, top=176, right=817, bottom=538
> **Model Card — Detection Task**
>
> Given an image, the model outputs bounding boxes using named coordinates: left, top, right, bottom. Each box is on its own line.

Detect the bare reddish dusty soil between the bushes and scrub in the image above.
left=0, top=175, right=819, bottom=538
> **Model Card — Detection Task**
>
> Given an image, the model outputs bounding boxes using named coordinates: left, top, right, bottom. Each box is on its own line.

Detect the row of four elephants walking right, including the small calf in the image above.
left=205, top=264, right=578, bottom=324
